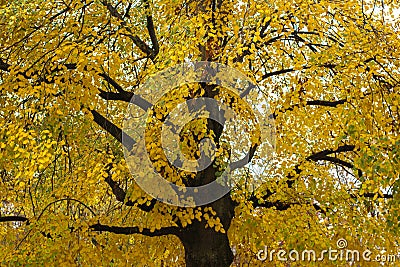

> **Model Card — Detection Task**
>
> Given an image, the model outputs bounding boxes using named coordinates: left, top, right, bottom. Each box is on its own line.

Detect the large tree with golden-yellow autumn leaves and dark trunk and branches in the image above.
left=0, top=0, right=400, bottom=266
